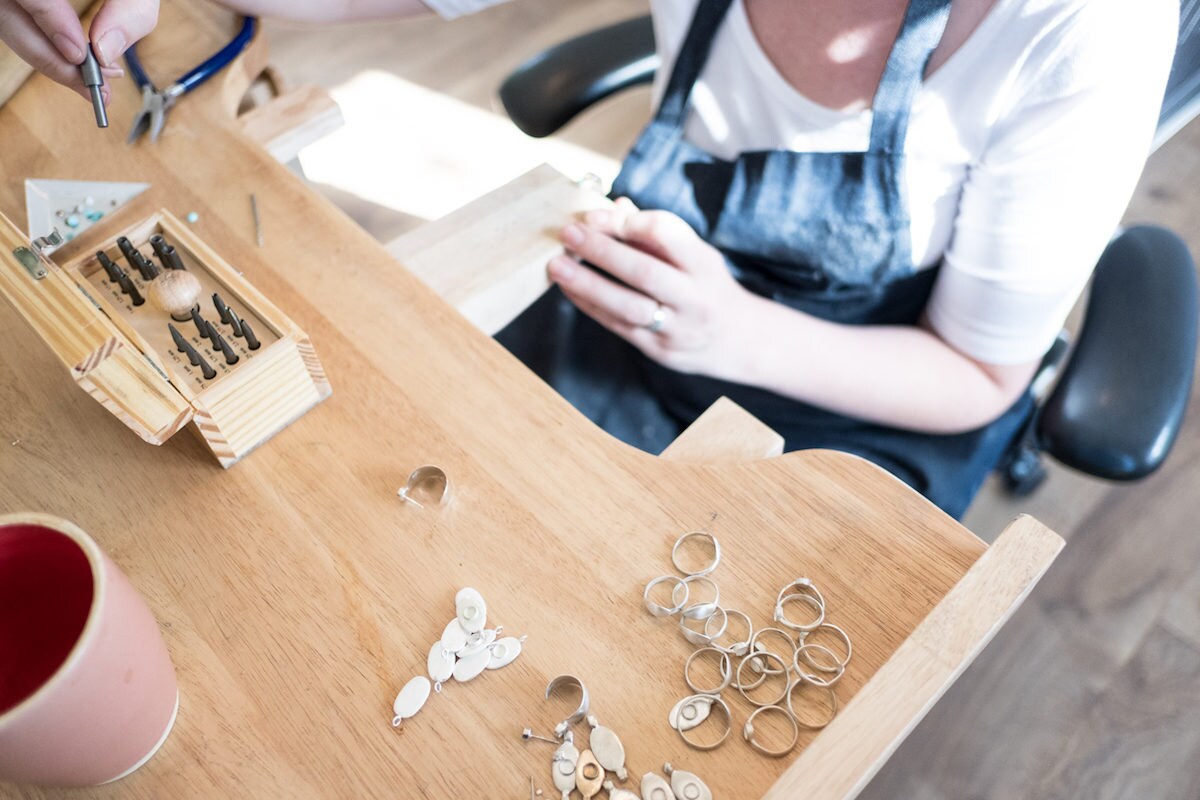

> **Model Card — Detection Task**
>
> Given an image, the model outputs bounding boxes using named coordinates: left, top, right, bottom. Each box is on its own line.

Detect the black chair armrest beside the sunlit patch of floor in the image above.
left=500, top=16, right=660, bottom=138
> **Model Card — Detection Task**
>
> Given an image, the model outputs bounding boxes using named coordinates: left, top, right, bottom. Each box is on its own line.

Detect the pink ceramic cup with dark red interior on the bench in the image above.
left=0, top=513, right=179, bottom=786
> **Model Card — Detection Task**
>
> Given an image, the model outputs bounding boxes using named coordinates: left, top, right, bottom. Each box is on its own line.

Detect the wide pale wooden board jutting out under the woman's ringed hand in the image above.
left=388, top=164, right=610, bottom=335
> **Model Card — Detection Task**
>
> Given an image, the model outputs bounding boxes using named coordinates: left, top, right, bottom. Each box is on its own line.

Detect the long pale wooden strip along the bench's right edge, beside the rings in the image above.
left=766, top=517, right=1063, bottom=800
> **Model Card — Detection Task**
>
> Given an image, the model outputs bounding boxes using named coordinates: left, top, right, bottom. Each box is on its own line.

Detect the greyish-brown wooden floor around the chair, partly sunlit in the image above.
left=271, top=0, right=1200, bottom=800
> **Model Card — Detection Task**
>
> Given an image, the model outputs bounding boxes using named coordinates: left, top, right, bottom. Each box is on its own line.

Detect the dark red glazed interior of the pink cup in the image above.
left=0, top=524, right=92, bottom=715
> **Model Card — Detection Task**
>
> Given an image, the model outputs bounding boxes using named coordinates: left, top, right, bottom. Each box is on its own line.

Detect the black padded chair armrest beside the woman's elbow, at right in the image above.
left=1038, top=225, right=1196, bottom=481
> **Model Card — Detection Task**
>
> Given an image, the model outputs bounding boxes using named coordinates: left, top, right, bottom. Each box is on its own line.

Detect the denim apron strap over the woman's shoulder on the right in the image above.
left=870, top=0, right=950, bottom=152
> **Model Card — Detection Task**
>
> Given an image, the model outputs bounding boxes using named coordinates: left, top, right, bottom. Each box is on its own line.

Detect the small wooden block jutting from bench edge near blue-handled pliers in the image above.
left=239, top=86, right=346, bottom=163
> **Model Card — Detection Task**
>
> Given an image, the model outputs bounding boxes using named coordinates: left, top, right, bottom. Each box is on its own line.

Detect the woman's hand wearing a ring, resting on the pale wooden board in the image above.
left=550, top=198, right=755, bottom=380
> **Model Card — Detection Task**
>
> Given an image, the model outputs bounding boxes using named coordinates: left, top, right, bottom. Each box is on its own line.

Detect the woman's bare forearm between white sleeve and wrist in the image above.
left=722, top=295, right=1037, bottom=433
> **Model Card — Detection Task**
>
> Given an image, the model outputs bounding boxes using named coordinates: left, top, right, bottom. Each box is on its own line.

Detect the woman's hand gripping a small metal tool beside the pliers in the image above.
left=0, top=0, right=158, bottom=103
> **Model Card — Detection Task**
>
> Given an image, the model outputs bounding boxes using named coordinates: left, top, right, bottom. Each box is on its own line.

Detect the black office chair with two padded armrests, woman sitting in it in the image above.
left=500, top=14, right=1200, bottom=494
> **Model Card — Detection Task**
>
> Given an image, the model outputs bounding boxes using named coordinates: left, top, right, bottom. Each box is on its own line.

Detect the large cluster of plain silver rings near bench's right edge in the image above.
left=642, top=530, right=853, bottom=758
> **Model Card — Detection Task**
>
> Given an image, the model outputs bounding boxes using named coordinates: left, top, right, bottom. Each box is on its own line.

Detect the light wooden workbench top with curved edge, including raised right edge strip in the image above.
left=0, top=2, right=1061, bottom=798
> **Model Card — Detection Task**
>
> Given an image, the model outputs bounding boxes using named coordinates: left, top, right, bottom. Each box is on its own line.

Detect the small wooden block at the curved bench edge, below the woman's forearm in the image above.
left=660, top=397, right=784, bottom=464
